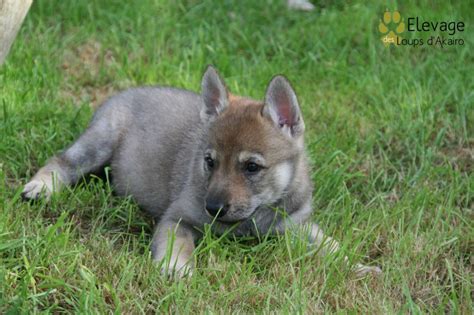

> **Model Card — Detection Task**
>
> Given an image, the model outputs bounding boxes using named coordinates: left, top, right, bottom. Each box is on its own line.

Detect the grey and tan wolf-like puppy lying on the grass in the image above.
left=23, top=67, right=380, bottom=275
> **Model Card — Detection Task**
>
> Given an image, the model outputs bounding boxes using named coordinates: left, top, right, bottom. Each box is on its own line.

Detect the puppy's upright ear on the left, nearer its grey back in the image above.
left=201, top=65, right=229, bottom=120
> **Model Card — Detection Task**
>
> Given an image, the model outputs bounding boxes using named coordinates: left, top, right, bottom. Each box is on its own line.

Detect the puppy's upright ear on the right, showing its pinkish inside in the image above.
left=262, top=75, right=304, bottom=137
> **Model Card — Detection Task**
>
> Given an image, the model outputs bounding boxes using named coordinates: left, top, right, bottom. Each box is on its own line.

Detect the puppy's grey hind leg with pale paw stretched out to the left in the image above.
left=22, top=104, right=121, bottom=199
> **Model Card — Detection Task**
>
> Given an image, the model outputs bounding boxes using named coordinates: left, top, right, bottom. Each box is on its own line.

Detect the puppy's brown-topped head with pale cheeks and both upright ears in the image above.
left=201, top=67, right=304, bottom=223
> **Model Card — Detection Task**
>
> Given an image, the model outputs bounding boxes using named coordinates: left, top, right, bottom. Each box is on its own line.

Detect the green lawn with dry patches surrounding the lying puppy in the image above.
left=0, top=0, right=474, bottom=314
